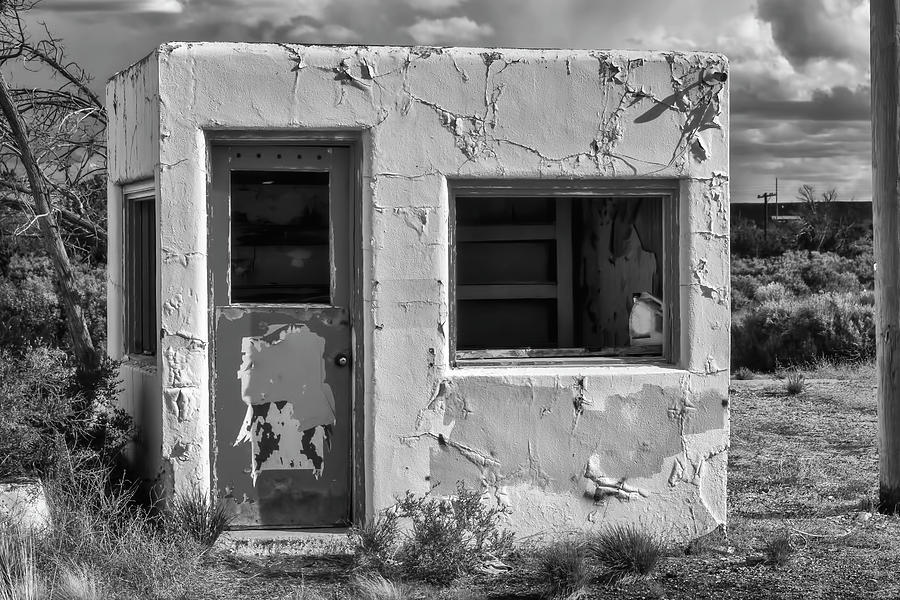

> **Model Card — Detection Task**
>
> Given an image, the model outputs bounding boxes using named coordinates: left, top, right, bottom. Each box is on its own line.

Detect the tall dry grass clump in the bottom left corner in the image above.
left=0, top=459, right=203, bottom=600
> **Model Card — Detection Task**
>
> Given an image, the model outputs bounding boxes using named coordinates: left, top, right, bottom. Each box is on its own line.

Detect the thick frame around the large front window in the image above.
left=448, top=179, right=680, bottom=367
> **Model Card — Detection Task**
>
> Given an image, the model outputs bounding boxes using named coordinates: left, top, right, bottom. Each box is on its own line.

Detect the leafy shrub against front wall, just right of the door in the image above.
left=395, top=483, right=513, bottom=584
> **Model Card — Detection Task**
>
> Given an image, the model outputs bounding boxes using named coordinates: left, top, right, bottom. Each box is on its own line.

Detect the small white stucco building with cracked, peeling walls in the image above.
left=107, top=43, right=730, bottom=538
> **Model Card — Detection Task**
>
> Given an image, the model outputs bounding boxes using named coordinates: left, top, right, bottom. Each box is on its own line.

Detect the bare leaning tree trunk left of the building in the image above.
left=0, top=73, right=100, bottom=372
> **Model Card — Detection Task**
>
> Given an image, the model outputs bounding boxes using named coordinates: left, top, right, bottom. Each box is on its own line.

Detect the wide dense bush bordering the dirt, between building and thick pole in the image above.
left=731, top=293, right=875, bottom=371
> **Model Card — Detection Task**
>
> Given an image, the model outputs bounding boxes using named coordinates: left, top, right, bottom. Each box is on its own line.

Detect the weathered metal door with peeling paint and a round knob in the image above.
left=209, top=145, right=353, bottom=528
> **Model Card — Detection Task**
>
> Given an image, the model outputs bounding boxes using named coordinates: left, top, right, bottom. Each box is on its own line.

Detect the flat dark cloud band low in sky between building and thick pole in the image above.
left=731, top=86, right=872, bottom=121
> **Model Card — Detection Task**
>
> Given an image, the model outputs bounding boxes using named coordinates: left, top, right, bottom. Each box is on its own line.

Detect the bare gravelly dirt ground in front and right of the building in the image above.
left=197, top=367, right=900, bottom=600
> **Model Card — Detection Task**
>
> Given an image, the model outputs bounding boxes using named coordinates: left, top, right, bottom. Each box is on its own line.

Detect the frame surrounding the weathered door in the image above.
left=203, top=129, right=366, bottom=523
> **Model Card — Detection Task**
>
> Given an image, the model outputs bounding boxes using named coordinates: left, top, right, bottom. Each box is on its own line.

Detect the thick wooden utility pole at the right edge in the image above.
left=869, top=0, right=900, bottom=513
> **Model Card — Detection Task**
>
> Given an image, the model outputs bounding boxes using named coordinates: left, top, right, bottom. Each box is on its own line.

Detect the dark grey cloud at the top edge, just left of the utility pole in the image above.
left=757, top=0, right=868, bottom=66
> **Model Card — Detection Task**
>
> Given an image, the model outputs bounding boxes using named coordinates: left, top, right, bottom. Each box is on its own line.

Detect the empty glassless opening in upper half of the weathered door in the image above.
left=231, top=171, right=331, bottom=304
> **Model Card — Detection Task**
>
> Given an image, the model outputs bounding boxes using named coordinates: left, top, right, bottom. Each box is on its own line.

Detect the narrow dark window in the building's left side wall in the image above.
left=123, top=182, right=159, bottom=356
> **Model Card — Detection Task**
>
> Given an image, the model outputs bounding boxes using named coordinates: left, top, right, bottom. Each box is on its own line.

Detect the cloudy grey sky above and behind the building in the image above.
left=32, top=0, right=871, bottom=201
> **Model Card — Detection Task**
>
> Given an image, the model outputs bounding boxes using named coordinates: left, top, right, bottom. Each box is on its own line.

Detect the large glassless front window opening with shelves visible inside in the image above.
left=452, top=184, right=677, bottom=361
